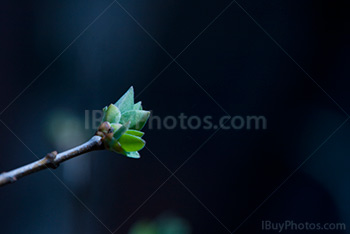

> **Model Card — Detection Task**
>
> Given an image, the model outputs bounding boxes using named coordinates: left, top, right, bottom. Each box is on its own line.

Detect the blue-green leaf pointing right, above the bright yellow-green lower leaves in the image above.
left=120, top=110, right=150, bottom=130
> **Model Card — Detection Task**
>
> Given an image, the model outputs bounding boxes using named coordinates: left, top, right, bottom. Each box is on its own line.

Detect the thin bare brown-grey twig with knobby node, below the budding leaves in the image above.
left=0, top=136, right=104, bottom=186
